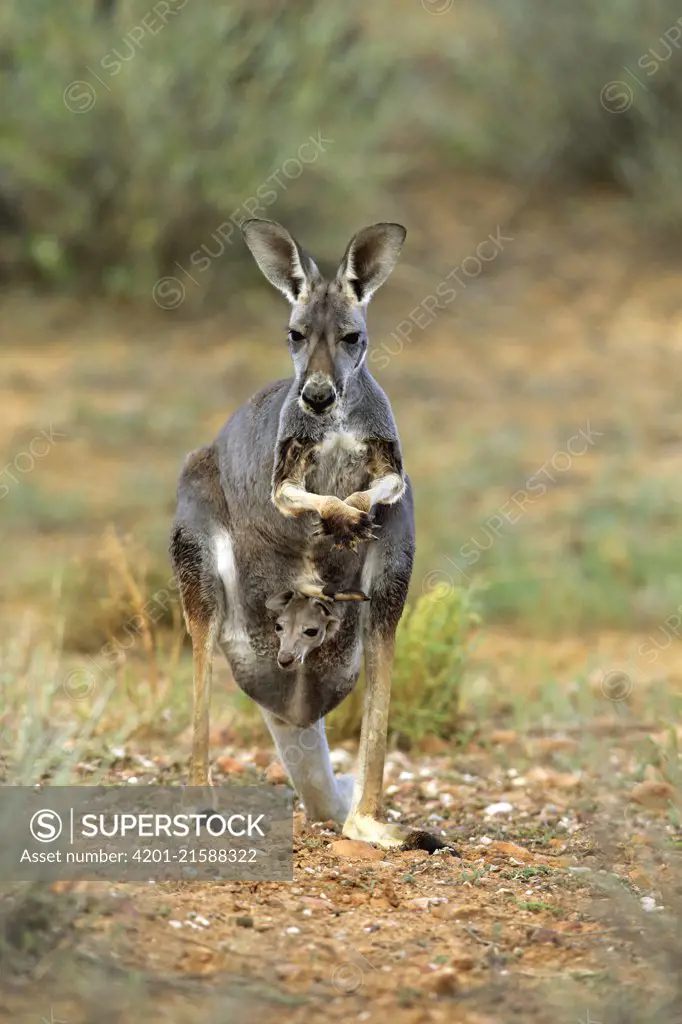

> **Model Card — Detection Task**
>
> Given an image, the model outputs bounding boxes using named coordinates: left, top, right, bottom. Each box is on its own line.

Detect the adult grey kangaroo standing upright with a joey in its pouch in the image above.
left=170, top=219, right=444, bottom=850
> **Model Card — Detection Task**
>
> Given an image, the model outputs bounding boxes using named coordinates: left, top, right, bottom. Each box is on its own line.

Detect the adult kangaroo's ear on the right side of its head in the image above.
left=336, top=223, right=408, bottom=303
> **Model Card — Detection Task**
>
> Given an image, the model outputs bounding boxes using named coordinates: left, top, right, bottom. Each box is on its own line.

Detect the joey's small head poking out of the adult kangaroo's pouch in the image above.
left=265, top=590, right=368, bottom=669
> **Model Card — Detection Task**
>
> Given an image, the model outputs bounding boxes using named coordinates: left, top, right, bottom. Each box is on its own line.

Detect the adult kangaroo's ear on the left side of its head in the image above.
left=242, top=217, right=322, bottom=305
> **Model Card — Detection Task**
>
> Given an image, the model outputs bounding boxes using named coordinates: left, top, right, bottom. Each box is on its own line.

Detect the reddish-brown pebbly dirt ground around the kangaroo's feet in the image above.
left=3, top=716, right=679, bottom=1024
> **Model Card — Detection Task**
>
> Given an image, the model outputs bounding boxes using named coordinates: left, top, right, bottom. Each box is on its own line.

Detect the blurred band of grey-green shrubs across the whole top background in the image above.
left=0, top=0, right=682, bottom=306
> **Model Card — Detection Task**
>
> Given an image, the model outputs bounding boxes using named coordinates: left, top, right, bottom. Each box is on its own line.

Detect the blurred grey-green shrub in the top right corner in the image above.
left=429, top=0, right=682, bottom=229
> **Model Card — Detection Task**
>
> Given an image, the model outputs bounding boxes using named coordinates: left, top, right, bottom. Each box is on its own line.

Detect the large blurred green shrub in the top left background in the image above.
left=0, top=0, right=399, bottom=307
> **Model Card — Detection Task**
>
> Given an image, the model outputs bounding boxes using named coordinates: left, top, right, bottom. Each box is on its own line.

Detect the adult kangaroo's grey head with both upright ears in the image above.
left=242, top=218, right=406, bottom=419
